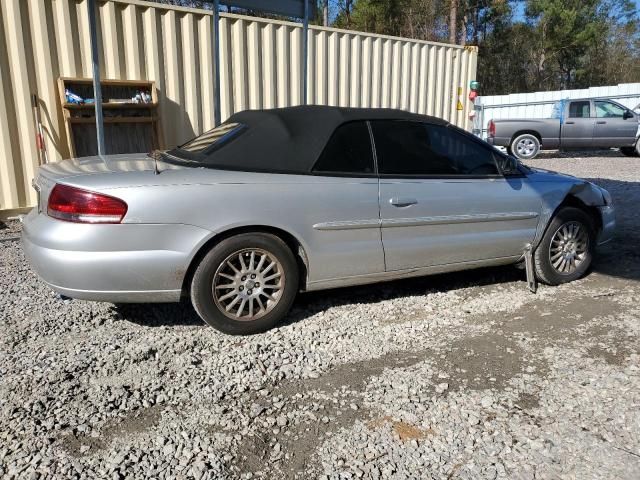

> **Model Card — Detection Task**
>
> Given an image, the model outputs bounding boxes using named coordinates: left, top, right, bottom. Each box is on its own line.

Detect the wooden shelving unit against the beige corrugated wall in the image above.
left=58, top=77, right=164, bottom=157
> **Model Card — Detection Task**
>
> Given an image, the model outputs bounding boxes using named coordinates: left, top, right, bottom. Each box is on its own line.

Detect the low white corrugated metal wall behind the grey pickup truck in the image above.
left=474, top=83, right=640, bottom=138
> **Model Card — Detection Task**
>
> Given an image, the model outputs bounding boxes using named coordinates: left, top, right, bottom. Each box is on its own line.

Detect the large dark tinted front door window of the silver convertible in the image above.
left=371, top=120, right=499, bottom=176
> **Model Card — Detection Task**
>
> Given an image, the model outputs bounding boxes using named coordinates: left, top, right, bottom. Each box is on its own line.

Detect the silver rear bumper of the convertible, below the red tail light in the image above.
left=22, top=209, right=210, bottom=303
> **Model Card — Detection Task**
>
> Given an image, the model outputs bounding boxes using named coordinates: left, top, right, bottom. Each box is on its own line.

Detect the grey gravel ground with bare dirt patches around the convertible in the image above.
left=0, top=155, right=640, bottom=479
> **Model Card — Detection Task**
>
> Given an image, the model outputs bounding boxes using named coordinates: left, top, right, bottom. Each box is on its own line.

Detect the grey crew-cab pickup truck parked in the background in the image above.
left=487, top=99, right=640, bottom=160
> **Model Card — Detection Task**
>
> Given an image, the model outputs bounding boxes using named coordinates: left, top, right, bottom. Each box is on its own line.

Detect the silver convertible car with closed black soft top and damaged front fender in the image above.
left=22, top=106, right=615, bottom=334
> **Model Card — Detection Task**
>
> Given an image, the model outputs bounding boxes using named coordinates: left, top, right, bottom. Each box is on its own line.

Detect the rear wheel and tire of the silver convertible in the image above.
left=191, top=233, right=298, bottom=335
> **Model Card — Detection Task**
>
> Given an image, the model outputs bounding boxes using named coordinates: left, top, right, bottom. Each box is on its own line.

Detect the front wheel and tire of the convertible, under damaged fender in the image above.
left=534, top=207, right=596, bottom=285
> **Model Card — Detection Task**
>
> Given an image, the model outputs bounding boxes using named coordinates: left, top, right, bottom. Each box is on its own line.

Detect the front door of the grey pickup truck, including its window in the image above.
left=593, top=100, right=638, bottom=148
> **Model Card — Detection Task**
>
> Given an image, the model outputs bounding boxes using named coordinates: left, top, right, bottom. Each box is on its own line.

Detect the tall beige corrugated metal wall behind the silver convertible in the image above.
left=0, top=0, right=477, bottom=211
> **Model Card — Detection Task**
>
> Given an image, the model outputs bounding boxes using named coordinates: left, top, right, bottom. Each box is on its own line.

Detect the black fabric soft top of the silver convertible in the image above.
left=169, top=105, right=447, bottom=174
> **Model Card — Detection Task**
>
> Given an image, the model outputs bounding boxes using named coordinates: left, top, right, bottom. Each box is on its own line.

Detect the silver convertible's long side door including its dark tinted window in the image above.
left=370, top=120, right=541, bottom=271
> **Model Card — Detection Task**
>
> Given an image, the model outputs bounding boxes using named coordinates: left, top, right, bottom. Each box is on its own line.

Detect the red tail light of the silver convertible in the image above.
left=47, top=184, right=127, bottom=223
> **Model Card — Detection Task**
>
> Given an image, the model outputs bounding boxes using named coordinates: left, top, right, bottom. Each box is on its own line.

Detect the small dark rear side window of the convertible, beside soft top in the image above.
left=313, top=122, right=375, bottom=175
